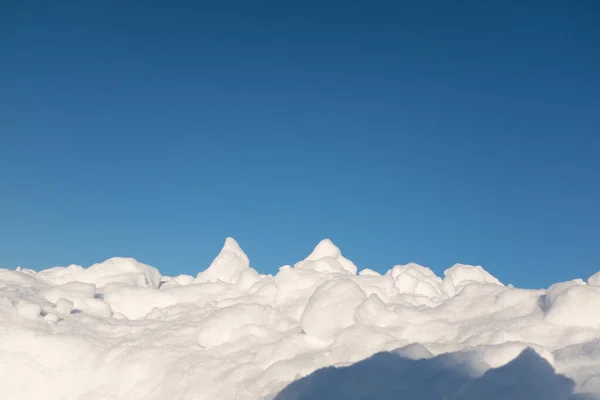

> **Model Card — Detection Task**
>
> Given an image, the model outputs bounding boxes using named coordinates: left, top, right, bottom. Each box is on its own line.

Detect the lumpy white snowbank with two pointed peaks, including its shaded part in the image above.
left=0, top=238, right=600, bottom=400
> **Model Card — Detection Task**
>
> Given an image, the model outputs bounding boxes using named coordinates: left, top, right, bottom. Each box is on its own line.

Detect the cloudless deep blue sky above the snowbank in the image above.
left=0, top=0, right=600, bottom=287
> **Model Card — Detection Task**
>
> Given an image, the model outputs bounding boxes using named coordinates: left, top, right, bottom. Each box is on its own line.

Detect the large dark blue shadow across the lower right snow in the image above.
left=274, top=349, right=600, bottom=400
